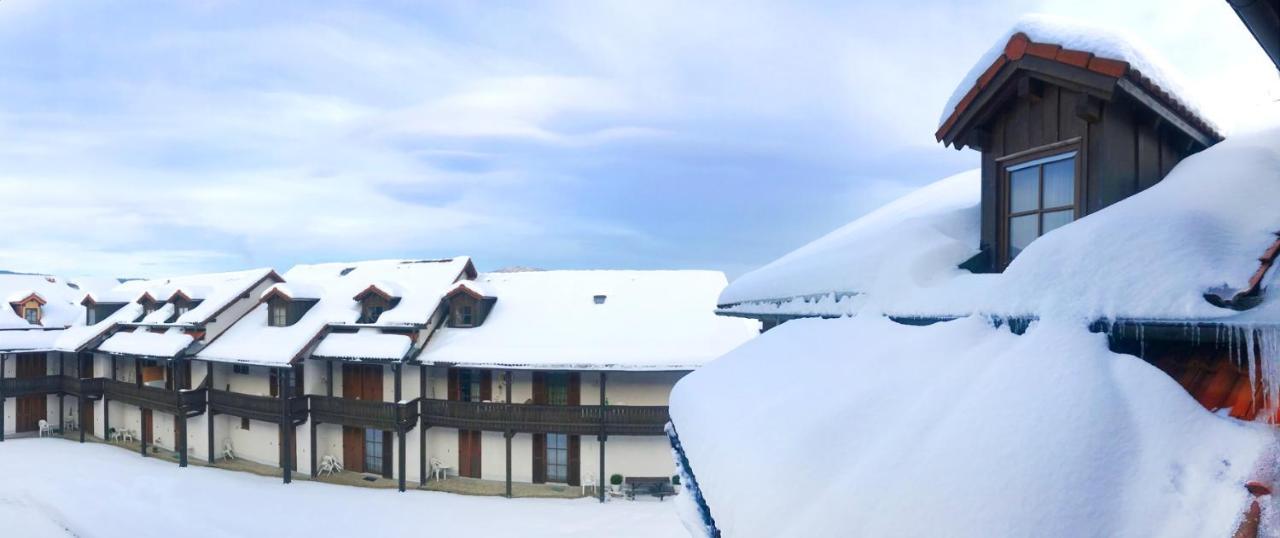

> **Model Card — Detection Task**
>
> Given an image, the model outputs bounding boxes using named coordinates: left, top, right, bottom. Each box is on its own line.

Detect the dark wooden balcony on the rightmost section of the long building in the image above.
left=422, top=400, right=671, bottom=436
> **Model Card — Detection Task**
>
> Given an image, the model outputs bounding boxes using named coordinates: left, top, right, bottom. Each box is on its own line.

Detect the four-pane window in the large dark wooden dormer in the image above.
left=1004, top=151, right=1076, bottom=264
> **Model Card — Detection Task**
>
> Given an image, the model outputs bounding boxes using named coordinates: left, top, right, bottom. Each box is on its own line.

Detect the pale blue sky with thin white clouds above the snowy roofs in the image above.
left=0, top=0, right=1280, bottom=277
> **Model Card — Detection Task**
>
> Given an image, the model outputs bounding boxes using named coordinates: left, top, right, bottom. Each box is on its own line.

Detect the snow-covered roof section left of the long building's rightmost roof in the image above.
left=197, top=256, right=474, bottom=366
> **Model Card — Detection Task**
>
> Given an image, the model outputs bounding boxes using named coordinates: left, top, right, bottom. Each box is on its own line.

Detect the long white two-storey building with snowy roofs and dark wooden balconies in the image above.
left=0, top=257, right=758, bottom=494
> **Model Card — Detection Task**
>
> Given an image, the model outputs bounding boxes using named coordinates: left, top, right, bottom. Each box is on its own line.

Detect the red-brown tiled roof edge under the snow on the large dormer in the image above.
left=933, top=32, right=1222, bottom=141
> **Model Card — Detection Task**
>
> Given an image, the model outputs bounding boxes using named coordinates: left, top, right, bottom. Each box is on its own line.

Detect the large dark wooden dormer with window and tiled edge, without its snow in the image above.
left=936, top=33, right=1222, bottom=272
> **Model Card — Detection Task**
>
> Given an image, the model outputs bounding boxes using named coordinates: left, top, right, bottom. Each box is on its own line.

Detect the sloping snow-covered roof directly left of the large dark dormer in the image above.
left=718, top=170, right=980, bottom=315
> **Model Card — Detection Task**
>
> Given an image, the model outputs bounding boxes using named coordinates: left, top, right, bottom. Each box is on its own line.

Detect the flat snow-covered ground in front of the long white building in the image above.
left=0, top=438, right=687, bottom=538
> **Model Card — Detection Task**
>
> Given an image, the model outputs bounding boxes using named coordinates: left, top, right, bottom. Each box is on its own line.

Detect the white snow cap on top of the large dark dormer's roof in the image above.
left=938, top=14, right=1220, bottom=131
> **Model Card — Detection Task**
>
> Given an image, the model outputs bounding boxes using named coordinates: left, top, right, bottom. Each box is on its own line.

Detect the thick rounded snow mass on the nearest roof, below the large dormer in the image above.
left=671, top=316, right=1275, bottom=538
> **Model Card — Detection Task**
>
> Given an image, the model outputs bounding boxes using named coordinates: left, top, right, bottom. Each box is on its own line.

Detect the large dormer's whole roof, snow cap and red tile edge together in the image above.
left=934, top=15, right=1222, bottom=149
